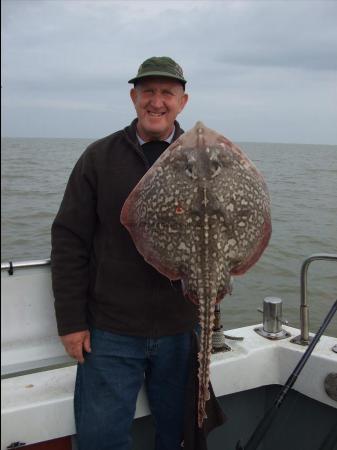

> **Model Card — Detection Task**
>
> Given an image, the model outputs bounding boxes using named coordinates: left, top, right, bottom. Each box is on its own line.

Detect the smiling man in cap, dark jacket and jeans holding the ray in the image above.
left=51, top=57, right=197, bottom=450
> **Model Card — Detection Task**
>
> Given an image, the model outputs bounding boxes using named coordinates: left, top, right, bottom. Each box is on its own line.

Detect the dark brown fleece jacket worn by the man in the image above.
left=51, top=119, right=197, bottom=337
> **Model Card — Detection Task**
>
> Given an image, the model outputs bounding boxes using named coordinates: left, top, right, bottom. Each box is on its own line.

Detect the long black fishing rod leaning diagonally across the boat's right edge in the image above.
left=235, top=300, right=337, bottom=450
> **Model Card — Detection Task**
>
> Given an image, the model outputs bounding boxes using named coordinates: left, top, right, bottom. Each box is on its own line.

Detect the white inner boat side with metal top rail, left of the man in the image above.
left=1, top=259, right=76, bottom=379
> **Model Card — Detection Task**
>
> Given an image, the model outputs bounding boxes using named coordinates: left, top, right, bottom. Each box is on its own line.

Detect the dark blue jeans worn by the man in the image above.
left=74, top=329, right=191, bottom=450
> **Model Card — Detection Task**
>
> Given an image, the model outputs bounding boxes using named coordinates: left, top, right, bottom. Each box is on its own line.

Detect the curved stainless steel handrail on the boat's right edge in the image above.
left=291, top=253, right=337, bottom=345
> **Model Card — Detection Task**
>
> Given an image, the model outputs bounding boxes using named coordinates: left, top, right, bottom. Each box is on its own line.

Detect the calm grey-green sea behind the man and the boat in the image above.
left=1, top=138, right=337, bottom=336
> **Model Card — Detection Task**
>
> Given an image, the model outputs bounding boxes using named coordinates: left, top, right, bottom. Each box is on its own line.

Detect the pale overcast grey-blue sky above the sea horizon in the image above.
left=1, top=0, right=337, bottom=145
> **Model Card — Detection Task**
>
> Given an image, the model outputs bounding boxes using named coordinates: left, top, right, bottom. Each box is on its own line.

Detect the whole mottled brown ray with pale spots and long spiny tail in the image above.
left=121, top=122, right=271, bottom=427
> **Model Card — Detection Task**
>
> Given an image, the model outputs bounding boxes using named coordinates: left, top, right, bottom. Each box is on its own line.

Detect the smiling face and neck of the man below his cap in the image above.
left=130, top=77, right=188, bottom=141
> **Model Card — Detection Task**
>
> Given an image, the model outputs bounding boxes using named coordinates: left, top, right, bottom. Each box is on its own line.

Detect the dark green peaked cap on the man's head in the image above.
left=128, top=56, right=187, bottom=86
